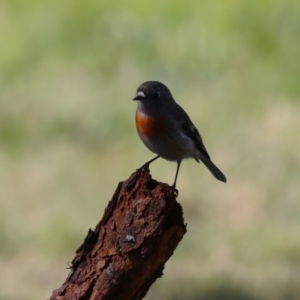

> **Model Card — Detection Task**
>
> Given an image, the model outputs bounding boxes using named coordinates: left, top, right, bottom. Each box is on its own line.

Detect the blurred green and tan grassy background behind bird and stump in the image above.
left=0, top=0, right=300, bottom=300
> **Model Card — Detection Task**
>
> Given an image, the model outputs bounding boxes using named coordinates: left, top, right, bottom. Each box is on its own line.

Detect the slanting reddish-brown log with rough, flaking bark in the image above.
left=50, top=170, right=186, bottom=300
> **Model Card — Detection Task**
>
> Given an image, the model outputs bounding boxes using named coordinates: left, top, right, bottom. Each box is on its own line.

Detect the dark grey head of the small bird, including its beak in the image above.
left=133, top=81, right=174, bottom=107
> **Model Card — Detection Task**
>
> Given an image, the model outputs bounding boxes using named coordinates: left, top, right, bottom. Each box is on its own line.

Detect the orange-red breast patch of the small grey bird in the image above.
left=135, top=110, right=163, bottom=140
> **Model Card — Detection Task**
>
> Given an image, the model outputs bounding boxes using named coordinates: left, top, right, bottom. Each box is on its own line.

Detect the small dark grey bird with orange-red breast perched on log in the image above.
left=133, top=81, right=226, bottom=189
